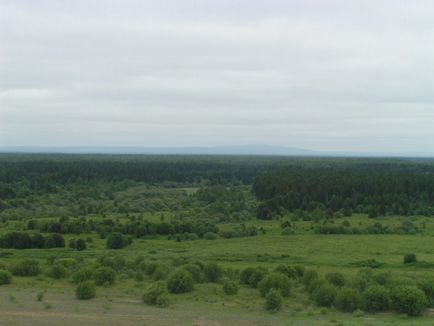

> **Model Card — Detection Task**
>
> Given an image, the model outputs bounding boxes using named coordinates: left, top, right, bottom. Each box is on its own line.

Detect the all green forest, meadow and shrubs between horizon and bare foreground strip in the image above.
left=0, top=155, right=434, bottom=325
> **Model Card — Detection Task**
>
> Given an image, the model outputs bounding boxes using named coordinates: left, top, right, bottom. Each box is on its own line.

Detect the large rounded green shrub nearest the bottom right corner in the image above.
left=392, top=286, right=427, bottom=316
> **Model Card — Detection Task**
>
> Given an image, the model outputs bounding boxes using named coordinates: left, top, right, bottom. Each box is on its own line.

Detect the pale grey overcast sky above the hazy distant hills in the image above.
left=0, top=0, right=434, bottom=153
